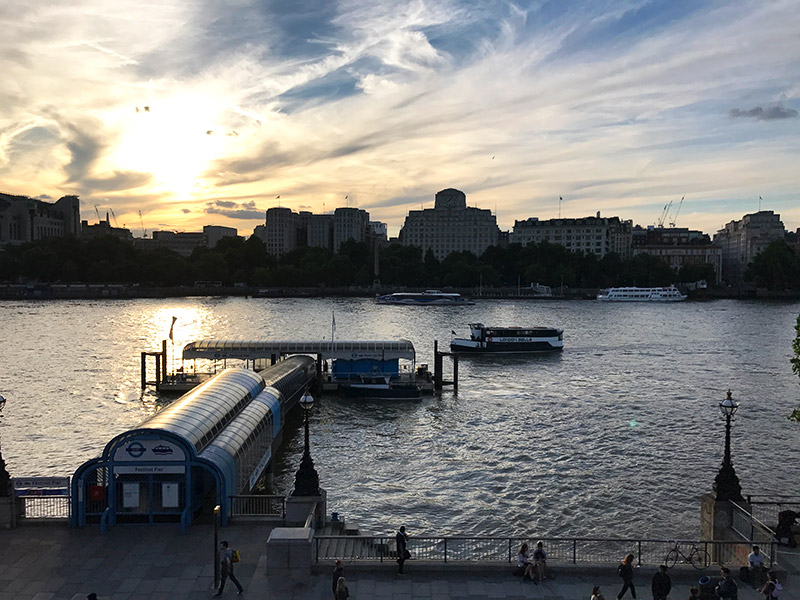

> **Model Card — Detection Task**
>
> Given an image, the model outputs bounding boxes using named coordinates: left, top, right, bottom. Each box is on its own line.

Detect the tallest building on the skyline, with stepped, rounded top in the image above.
left=399, top=188, right=500, bottom=260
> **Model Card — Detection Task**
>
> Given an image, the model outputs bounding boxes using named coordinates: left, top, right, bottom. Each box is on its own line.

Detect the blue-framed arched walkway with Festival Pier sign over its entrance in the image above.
left=72, top=356, right=317, bottom=529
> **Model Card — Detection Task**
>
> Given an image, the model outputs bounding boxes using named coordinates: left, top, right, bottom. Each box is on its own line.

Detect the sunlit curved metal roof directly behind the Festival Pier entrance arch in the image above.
left=134, top=368, right=265, bottom=452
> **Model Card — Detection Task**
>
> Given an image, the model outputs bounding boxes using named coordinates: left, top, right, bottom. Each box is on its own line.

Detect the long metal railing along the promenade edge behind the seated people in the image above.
left=315, top=535, right=776, bottom=566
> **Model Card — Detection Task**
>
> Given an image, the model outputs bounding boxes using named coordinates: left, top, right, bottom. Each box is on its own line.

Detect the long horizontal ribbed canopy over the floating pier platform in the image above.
left=183, top=340, right=416, bottom=361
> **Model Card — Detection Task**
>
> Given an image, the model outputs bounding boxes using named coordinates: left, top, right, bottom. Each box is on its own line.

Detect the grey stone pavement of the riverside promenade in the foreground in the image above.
left=0, top=524, right=800, bottom=600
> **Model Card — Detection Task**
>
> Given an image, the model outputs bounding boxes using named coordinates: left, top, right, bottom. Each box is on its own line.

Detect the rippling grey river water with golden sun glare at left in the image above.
left=0, top=298, right=800, bottom=538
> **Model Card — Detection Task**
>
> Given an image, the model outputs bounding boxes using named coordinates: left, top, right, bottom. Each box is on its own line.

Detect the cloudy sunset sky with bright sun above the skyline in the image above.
left=0, top=0, right=800, bottom=237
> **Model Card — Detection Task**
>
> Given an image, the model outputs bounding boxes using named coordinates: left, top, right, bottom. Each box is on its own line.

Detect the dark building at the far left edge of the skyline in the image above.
left=0, top=194, right=81, bottom=246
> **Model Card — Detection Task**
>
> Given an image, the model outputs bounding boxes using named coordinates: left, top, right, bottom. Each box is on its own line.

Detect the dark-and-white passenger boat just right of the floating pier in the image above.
left=450, top=323, right=564, bottom=354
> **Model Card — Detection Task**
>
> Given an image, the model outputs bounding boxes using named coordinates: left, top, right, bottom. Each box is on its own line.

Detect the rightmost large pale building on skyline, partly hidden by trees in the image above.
left=714, top=210, right=785, bottom=285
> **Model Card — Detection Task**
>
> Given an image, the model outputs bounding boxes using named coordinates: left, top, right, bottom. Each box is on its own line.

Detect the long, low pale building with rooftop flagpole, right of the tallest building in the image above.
left=511, top=213, right=633, bottom=258
